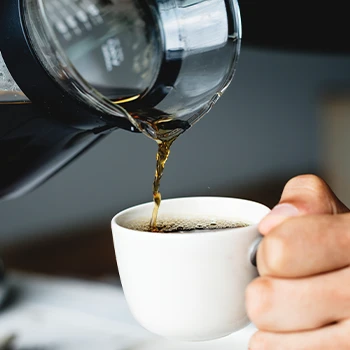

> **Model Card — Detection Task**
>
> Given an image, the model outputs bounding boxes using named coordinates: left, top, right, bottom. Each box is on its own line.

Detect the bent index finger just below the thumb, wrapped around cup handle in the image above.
left=257, top=213, right=350, bottom=278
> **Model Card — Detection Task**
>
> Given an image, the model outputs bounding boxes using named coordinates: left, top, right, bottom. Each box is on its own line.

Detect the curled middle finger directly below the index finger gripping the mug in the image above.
left=246, top=268, right=350, bottom=332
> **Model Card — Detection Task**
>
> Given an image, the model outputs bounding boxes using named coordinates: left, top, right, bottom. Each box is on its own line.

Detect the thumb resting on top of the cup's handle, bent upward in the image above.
left=259, top=175, right=349, bottom=235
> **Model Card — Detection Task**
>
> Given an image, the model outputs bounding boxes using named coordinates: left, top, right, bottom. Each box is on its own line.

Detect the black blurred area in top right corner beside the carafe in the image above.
left=239, top=0, right=350, bottom=54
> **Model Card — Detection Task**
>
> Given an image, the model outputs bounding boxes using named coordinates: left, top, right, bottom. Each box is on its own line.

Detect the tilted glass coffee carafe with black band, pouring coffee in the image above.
left=0, top=0, right=241, bottom=198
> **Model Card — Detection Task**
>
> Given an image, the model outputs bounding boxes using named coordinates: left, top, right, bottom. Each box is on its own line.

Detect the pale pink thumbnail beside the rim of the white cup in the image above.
left=259, top=203, right=299, bottom=234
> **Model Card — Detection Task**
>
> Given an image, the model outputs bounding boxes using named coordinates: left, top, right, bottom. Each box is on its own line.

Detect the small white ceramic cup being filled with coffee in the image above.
left=112, top=197, right=270, bottom=341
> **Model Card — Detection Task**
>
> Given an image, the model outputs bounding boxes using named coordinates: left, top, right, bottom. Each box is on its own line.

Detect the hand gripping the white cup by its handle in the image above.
left=246, top=175, right=350, bottom=350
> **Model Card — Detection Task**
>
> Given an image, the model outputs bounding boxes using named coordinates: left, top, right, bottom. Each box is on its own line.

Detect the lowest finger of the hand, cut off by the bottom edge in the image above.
left=249, top=321, right=350, bottom=350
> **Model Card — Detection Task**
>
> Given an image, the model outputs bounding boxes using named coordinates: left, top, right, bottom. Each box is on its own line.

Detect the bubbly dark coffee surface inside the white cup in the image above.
left=126, top=218, right=250, bottom=233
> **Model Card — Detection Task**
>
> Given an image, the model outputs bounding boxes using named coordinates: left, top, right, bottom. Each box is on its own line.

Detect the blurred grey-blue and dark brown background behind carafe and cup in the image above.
left=0, top=0, right=350, bottom=284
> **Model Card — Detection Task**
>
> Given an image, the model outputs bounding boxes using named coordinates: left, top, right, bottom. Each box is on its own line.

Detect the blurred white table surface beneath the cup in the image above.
left=0, top=272, right=255, bottom=350
